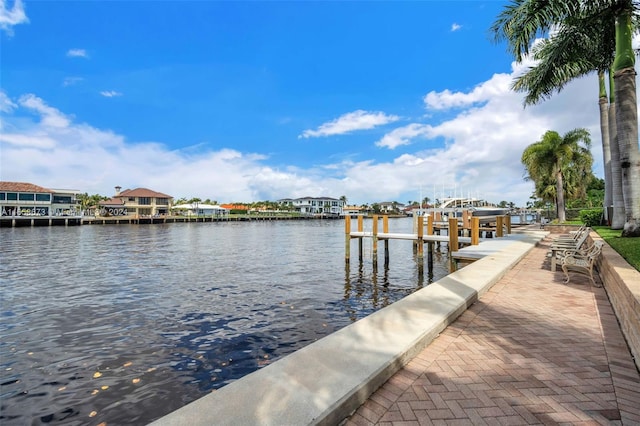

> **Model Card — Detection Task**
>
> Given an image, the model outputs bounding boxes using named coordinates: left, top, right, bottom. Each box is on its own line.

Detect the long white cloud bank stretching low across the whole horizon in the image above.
left=0, top=52, right=636, bottom=205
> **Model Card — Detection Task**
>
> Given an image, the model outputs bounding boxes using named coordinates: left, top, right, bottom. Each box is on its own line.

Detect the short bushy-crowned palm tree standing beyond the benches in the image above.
left=522, top=129, right=593, bottom=222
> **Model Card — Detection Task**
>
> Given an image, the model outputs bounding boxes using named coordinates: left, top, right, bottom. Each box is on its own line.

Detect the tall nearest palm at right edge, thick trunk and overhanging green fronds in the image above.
left=491, top=0, right=640, bottom=236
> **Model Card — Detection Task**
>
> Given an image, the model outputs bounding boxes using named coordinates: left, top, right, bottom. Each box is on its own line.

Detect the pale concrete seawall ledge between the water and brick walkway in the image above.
left=152, top=231, right=547, bottom=426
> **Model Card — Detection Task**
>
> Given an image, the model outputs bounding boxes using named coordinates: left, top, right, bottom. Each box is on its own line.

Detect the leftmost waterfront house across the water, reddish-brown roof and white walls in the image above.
left=0, top=181, right=80, bottom=216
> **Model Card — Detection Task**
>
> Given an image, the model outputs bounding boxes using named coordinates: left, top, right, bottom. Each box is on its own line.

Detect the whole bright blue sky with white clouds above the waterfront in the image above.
left=0, top=0, right=636, bottom=205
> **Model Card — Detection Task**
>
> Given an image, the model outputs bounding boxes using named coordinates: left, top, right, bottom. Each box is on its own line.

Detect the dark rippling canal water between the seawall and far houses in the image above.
left=0, top=219, right=447, bottom=425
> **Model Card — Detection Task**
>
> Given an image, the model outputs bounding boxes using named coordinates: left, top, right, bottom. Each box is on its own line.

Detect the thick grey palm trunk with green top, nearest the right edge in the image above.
left=613, top=11, right=640, bottom=237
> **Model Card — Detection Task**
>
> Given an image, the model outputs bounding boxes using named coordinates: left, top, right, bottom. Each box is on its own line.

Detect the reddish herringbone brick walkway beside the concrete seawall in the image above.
left=344, top=236, right=640, bottom=426
